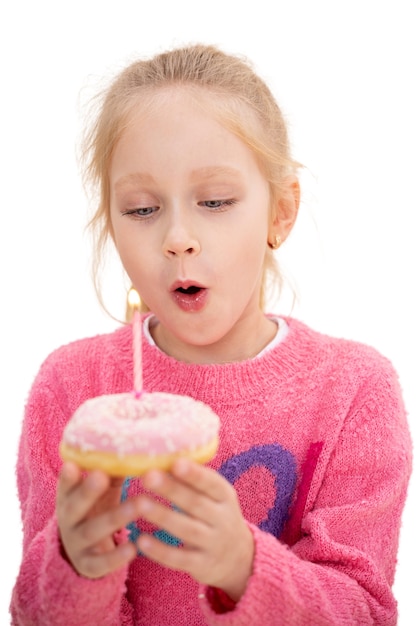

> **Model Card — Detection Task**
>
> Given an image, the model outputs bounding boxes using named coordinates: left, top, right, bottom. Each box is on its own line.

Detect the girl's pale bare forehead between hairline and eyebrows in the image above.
left=111, top=85, right=263, bottom=175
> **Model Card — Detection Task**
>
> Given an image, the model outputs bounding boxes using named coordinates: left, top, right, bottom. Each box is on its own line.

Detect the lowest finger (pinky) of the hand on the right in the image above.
left=138, top=496, right=211, bottom=547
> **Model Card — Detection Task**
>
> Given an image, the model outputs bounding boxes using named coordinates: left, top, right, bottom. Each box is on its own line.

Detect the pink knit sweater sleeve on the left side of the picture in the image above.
left=10, top=356, right=133, bottom=626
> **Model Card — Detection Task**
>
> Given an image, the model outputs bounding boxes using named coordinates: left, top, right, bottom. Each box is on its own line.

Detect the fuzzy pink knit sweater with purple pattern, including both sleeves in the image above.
left=11, top=319, right=411, bottom=626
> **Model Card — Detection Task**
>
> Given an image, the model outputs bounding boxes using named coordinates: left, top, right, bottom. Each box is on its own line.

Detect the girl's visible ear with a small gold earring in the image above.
left=268, top=176, right=300, bottom=243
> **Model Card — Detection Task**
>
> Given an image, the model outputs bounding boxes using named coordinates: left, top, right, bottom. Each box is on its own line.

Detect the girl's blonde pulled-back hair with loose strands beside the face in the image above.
left=82, top=45, right=298, bottom=308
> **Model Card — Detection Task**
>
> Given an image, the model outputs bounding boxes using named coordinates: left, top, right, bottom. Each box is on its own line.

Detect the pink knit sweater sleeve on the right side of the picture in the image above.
left=200, top=354, right=411, bottom=626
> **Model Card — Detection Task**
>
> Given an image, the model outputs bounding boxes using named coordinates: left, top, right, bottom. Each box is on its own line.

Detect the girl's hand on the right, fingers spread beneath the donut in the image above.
left=137, top=459, right=254, bottom=601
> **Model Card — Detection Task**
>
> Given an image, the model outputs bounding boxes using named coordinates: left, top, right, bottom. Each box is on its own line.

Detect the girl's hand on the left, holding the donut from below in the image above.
left=56, top=462, right=138, bottom=578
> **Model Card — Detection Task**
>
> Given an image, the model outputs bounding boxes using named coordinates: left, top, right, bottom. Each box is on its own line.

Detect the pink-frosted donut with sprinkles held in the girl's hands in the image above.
left=60, top=392, right=220, bottom=477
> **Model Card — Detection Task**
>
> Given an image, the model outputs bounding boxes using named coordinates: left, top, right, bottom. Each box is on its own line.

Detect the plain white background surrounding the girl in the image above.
left=0, top=0, right=417, bottom=626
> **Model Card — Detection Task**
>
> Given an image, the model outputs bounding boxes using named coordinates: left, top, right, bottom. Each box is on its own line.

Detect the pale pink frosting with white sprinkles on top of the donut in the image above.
left=63, top=393, right=220, bottom=456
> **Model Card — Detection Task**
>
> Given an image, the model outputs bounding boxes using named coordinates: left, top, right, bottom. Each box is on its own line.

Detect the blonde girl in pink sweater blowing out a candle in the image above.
left=11, top=46, right=411, bottom=626
